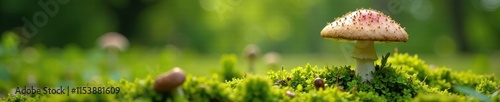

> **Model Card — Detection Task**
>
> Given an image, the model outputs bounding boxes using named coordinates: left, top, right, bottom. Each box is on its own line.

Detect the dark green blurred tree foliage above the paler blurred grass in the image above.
left=0, top=0, right=500, bottom=54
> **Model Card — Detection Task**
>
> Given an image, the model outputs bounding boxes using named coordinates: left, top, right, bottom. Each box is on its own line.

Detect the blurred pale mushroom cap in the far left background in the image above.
left=99, top=32, right=128, bottom=51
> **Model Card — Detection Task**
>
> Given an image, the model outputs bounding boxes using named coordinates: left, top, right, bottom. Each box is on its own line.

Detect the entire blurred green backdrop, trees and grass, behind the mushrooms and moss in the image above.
left=0, top=0, right=500, bottom=81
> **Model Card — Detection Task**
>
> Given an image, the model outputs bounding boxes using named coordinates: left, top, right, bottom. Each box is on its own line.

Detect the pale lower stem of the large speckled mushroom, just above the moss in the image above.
left=356, top=59, right=375, bottom=82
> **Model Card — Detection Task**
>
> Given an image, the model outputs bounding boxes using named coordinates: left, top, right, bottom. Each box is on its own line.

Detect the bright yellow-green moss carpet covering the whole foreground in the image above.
left=2, top=53, right=500, bottom=102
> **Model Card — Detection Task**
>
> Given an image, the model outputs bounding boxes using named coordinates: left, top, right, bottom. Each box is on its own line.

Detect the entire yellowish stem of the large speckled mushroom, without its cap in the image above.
left=352, top=41, right=378, bottom=82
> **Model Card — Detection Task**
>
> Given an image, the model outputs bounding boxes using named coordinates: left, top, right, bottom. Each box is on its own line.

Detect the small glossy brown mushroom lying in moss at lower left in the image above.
left=153, top=67, right=186, bottom=96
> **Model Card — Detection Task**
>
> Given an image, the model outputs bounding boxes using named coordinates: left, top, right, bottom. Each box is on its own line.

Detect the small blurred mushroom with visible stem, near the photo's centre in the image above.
left=244, top=44, right=260, bottom=72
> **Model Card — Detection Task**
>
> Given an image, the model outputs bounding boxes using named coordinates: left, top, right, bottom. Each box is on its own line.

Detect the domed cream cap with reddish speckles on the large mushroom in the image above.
left=321, top=9, right=408, bottom=42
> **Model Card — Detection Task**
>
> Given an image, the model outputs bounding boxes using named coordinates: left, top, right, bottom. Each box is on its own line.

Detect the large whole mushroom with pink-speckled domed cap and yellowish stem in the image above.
left=321, top=9, right=408, bottom=82
